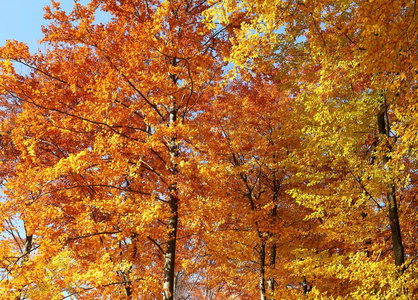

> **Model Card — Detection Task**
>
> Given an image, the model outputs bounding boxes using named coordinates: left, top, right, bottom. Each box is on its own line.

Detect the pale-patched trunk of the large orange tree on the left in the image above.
left=163, top=103, right=179, bottom=300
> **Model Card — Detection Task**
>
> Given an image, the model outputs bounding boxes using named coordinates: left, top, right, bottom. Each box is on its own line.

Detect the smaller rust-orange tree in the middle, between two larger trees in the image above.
left=189, top=73, right=320, bottom=299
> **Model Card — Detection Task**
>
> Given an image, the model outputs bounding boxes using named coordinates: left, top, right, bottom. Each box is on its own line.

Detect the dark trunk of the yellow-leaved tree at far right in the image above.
left=377, top=102, right=405, bottom=266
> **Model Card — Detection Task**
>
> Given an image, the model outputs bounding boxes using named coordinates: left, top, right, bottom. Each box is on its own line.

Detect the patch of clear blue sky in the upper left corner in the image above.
left=0, top=0, right=85, bottom=53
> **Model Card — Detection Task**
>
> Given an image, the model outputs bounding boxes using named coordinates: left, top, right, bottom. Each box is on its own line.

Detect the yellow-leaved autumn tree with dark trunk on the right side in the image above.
left=208, top=1, right=418, bottom=299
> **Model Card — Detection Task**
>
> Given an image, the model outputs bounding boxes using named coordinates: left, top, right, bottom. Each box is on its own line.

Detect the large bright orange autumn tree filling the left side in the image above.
left=0, top=0, right=228, bottom=299
